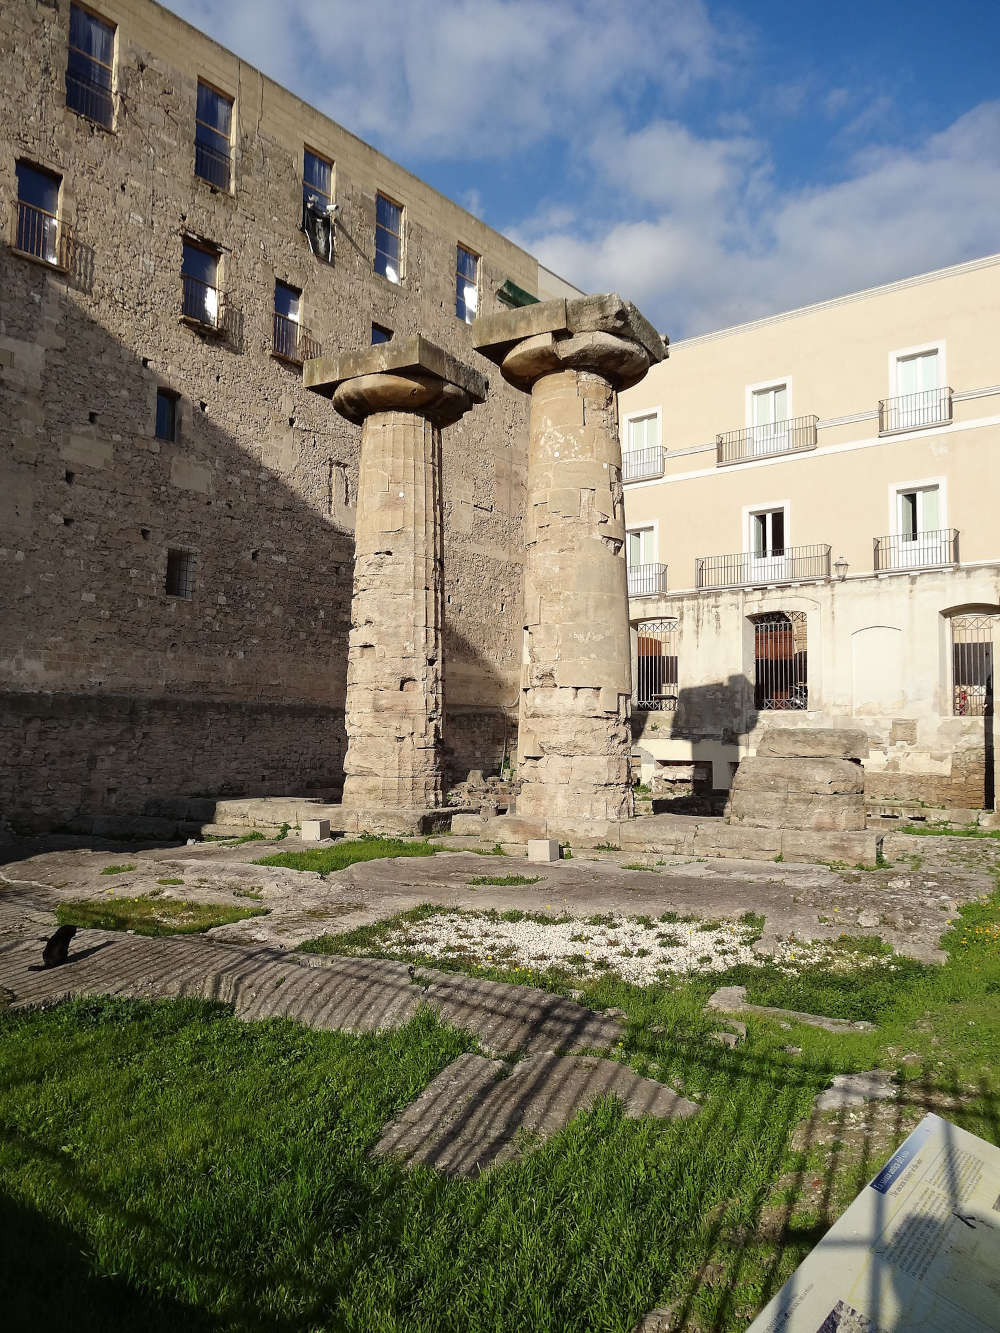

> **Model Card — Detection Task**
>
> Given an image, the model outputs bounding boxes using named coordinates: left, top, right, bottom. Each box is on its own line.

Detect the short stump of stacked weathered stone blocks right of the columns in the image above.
left=727, top=726, right=868, bottom=833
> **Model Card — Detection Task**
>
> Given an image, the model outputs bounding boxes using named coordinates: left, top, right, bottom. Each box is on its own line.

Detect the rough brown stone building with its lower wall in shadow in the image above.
left=0, top=0, right=575, bottom=822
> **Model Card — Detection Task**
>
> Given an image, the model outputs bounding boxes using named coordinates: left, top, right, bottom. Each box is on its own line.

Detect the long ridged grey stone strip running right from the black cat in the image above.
left=0, top=914, right=624, bottom=1056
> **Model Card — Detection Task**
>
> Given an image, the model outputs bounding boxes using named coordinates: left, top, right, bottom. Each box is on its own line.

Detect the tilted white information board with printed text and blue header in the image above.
left=748, top=1116, right=1000, bottom=1333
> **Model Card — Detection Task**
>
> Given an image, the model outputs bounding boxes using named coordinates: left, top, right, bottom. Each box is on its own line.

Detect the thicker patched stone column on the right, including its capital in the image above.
left=473, top=296, right=667, bottom=820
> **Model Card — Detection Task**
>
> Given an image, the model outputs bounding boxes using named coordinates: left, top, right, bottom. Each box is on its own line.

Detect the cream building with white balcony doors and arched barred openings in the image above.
left=620, top=255, right=1000, bottom=808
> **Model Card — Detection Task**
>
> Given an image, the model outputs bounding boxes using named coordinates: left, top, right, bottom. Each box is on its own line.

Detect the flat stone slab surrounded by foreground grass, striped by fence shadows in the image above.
left=372, top=1052, right=699, bottom=1176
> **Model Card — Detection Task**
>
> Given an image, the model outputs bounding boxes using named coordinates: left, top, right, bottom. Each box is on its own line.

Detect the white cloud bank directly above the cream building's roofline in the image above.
left=516, top=101, right=1000, bottom=335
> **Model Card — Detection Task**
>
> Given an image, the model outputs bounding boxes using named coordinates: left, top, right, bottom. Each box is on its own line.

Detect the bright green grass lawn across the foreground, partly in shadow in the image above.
left=7, top=894, right=1000, bottom=1333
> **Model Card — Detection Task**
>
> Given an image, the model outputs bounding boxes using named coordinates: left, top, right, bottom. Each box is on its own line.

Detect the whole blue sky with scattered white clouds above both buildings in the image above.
left=169, top=0, right=1000, bottom=337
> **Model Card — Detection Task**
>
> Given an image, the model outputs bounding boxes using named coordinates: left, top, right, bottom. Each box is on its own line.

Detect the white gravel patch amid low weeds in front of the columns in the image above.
left=381, top=910, right=892, bottom=985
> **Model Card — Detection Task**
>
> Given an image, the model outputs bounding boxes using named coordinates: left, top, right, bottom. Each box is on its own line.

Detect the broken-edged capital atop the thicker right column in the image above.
left=472, top=293, right=667, bottom=391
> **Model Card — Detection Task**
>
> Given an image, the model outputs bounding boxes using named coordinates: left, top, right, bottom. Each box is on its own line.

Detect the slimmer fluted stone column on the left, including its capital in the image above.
left=309, top=337, right=487, bottom=809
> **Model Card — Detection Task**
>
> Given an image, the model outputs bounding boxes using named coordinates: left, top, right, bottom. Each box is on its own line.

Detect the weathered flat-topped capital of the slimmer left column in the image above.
left=303, top=335, right=487, bottom=427
